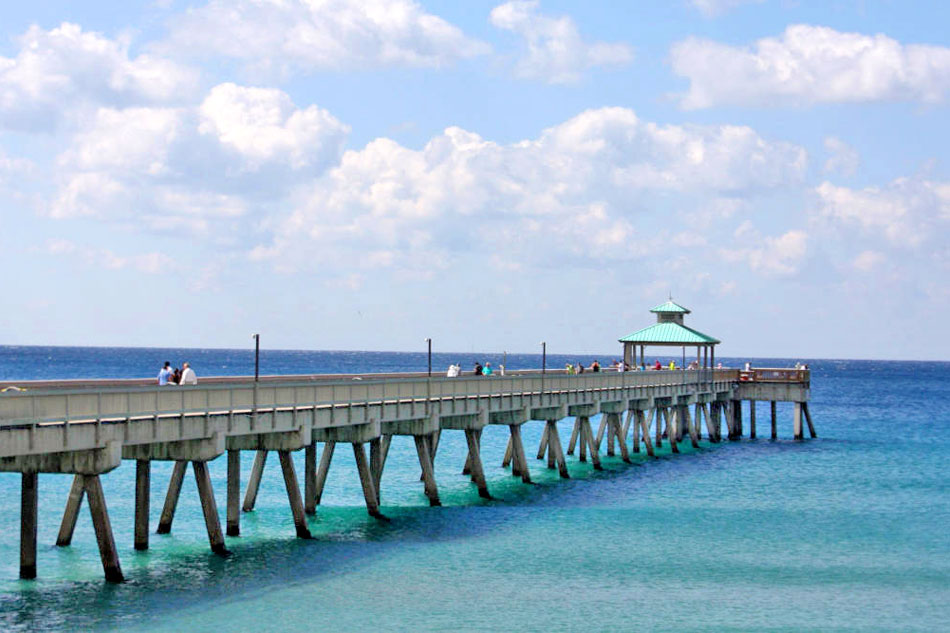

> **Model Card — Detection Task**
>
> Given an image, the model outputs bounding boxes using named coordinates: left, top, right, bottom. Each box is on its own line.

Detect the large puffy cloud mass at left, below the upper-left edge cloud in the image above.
left=48, top=84, right=349, bottom=239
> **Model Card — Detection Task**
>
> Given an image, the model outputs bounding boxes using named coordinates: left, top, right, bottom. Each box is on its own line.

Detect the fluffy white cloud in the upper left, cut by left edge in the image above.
left=0, top=23, right=196, bottom=130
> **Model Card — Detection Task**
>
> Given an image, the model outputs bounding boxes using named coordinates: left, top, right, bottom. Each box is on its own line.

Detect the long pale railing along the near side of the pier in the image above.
left=0, top=369, right=764, bottom=427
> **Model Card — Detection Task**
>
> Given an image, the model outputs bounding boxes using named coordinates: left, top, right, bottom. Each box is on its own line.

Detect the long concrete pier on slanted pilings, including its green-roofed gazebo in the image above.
left=0, top=300, right=816, bottom=582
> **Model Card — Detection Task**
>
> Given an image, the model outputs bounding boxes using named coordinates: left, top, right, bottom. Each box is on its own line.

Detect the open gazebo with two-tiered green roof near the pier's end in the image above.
left=620, top=297, right=721, bottom=369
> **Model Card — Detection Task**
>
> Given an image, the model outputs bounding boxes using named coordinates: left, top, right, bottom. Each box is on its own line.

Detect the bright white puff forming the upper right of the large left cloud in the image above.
left=199, top=83, right=350, bottom=169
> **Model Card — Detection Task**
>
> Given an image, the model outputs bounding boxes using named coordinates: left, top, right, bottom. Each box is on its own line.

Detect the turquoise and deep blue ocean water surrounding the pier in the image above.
left=0, top=348, right=950, bottom=631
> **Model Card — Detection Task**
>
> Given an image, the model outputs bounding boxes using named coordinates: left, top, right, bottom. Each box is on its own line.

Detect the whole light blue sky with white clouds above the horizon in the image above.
left=0, top=0, right=950, bottom=360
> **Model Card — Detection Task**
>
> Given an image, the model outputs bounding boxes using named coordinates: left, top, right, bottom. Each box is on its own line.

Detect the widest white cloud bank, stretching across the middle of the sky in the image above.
left=254, top=108, right=805, bottom=272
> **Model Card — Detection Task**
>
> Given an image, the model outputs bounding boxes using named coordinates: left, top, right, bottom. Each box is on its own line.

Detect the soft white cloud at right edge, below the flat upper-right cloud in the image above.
left=815, top=178, right=950, bottom=248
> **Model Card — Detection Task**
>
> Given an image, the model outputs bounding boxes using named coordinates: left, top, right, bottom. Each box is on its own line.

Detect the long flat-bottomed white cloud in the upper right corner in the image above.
left=671, top=24, right=950, bottom=109
